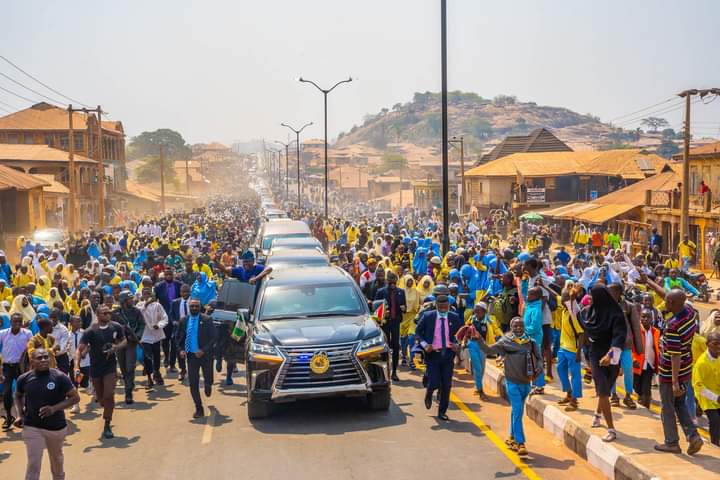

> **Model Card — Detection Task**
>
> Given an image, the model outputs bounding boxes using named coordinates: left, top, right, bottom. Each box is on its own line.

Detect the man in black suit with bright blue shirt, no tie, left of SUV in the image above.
left=175, top=298, right=217, bottom=418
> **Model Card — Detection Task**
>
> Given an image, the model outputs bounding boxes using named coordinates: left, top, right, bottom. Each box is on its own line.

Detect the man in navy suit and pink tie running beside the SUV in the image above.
left=415, top=285, right=463, bottom=421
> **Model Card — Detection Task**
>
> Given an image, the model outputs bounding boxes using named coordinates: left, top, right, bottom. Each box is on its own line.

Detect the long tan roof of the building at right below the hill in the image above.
left=465, top=149, right=667, bottom=180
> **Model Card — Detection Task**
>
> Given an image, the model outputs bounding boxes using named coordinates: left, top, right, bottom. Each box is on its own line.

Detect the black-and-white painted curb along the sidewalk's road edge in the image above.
left=483, top=362, right=660, bottom=480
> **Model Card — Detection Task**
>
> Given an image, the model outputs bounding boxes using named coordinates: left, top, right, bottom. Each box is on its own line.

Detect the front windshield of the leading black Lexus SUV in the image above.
left=259, top=284, right=365, bottom=320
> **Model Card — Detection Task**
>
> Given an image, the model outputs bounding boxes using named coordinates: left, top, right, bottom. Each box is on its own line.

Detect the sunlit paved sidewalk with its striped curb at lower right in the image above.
left=472, top=360, right=720, bottom=480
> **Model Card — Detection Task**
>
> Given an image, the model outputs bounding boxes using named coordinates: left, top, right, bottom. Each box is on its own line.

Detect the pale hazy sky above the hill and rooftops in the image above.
left=0, top=0, right=720, bottom=142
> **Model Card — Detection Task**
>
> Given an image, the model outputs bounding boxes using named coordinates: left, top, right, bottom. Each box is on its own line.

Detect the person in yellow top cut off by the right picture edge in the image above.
left=692, top=332, right=720, bottom=446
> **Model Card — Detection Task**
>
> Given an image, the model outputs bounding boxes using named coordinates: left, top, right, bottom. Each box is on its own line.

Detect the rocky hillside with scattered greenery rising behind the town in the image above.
left=337, top=91, right=616, bottom=151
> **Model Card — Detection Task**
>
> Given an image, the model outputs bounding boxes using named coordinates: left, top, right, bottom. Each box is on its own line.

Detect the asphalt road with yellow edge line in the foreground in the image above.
left=0, top=362, right=601, bottom=480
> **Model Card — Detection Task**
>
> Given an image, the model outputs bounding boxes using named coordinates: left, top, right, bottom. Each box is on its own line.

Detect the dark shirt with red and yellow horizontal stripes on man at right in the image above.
left=658, top=306, right=698, bottom=383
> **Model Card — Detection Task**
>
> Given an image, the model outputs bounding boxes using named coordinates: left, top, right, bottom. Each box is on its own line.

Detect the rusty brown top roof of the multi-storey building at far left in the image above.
left=0, top=102, right=124, bottom=134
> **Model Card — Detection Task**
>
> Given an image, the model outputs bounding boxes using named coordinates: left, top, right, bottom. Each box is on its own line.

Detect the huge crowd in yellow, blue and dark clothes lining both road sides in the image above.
left=0, top=188, right=720, bottom=474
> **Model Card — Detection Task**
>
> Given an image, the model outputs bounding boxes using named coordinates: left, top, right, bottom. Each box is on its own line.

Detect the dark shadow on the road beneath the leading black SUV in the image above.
left=252, top=398, right=410, bottom=435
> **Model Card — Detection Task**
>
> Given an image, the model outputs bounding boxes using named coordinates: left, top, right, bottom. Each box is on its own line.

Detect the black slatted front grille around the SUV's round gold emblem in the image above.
left=276, top=342, right=365, bottom=390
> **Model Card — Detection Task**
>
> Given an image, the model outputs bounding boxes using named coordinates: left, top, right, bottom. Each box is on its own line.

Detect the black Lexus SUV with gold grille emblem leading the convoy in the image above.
left=246, top=266, right=390, bottom=419
